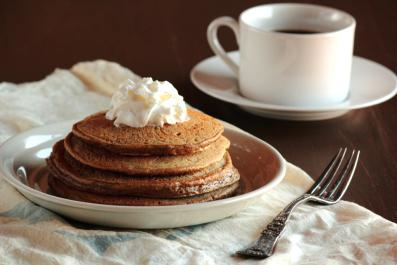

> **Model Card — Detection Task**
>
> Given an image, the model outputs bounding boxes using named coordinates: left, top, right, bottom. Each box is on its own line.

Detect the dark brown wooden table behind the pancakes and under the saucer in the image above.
left=0, top=0, right=397, bottom=222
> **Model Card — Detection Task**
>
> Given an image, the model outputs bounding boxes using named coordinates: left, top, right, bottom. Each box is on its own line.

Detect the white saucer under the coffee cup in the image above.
left=190, top=51, right=397, bottom=120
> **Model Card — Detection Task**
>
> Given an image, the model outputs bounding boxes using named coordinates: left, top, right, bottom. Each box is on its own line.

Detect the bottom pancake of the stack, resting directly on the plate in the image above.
left=48, top=175, right=238, bottom=206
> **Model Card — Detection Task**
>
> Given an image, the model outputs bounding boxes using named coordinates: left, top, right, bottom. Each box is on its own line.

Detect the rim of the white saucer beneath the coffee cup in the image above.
left=190, top=50, right=397, bottom=113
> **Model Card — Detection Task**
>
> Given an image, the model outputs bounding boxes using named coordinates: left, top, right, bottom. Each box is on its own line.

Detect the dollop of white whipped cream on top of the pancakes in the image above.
left=106, top=77, right=189, bottom=127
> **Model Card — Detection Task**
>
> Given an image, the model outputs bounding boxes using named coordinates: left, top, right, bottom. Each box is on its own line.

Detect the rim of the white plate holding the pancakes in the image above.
left=0, top=120, right=287, bottom=213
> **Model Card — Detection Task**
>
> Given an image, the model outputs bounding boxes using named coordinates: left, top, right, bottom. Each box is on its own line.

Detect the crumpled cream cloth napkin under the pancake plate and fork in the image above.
left=0, top=66, right=397, bottom=265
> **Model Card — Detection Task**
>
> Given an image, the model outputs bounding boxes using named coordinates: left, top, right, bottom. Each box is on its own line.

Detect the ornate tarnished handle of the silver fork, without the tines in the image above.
left=251, top=194, right=311, bottom=257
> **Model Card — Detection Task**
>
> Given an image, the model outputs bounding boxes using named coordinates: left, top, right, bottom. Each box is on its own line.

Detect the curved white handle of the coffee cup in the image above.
left=207, top=17, right=240, bottom=76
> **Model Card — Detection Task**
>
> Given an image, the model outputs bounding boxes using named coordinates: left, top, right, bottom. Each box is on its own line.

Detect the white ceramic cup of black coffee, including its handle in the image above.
left=207, top=4, right=356, bottom=106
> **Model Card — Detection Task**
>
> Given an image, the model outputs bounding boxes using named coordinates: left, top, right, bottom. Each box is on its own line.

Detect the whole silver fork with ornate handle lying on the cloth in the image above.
left=237, top=148, right=360, bottom=259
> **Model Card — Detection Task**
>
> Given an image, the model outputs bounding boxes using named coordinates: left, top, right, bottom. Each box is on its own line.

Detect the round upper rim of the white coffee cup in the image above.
left=239, top=3, right=356, bottom=38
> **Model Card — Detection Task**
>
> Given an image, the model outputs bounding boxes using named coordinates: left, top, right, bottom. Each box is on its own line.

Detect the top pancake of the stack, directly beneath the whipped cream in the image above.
left=72, top=109, right=223, bottom=156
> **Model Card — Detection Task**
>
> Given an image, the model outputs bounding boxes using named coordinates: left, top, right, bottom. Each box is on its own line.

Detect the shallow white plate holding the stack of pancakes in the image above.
left=0, top=121, right=286, bottom=229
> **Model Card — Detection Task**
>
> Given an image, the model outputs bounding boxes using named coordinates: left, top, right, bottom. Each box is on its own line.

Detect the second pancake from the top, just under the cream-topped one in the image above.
left=64, top=134, right=230, bottom=175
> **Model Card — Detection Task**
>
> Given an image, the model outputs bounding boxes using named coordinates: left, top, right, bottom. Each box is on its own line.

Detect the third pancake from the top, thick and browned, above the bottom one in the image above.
left=47, top=141, right=239, bottom=198
